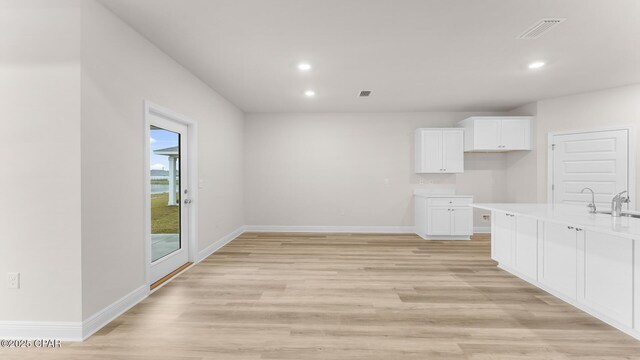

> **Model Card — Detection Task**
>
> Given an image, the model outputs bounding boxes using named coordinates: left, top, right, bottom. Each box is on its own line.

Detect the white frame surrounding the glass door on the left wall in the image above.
left=143, top=100, right=198, bottom=286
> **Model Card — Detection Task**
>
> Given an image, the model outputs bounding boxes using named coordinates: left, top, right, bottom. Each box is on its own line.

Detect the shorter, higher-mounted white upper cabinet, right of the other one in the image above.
left=458, top=116, right=532, bottom=152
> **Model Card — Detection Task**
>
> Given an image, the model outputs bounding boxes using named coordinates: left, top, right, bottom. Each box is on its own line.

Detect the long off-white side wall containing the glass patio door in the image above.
left=77, top=1, right=245, bottom=319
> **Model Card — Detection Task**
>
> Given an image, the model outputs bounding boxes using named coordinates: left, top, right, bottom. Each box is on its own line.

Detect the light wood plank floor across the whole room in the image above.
left=0, top=233, right=640, bottom=360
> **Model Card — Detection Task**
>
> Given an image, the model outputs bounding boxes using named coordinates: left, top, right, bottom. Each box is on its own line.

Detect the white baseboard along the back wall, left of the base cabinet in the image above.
left=245, top=225, right=415, bottom=234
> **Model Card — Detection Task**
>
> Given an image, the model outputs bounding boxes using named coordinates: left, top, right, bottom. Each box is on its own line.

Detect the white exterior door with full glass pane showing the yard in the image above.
left=147, top=115, right=190, bottom=283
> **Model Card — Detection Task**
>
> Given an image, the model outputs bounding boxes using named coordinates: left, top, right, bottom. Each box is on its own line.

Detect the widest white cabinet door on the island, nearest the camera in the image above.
left=578, top=231, right=633, bottom=327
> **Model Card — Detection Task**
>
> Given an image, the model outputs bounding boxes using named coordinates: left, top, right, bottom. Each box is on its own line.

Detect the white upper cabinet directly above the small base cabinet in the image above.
left=415, top=128, right=464, bottom=173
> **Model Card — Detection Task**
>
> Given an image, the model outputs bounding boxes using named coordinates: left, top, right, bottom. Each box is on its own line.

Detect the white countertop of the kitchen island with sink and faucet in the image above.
left=471, top=204, right=640, bottom=240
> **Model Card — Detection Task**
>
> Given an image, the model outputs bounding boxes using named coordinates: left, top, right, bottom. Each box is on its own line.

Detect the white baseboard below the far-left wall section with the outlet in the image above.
left=0, top=321, right=82, bottom=341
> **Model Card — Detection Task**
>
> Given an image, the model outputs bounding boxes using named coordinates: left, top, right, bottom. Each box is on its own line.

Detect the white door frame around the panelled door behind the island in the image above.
left=547, top=125, right=636, bottom=210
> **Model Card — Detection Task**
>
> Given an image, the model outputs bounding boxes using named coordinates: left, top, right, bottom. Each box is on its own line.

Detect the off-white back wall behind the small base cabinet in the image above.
left=245, top=112, right=506, bottom=227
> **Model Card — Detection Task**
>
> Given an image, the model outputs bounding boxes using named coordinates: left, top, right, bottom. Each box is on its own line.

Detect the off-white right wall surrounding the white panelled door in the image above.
left=536, top=85, right=640, bottom=205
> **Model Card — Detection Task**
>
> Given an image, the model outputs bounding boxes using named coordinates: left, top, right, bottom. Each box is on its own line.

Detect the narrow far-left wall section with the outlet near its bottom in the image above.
left=0, top=0, right=81, bottom=322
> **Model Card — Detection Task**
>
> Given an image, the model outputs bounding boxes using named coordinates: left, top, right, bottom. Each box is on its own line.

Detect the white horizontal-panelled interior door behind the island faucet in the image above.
left=551, top=129, right=634, bottom=209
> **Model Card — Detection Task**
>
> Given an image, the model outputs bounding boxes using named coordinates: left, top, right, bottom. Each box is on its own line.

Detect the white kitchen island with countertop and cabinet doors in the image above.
left=472, top=204, right=640, bottom=339
